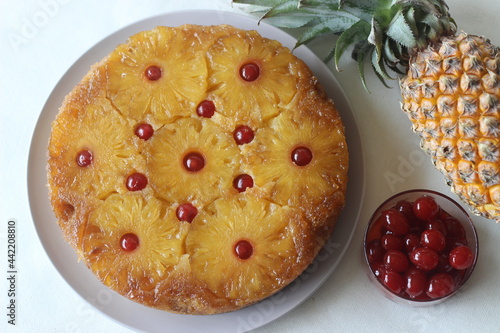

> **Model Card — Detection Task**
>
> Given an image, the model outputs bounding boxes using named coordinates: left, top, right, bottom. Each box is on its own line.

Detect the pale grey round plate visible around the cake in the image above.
left=28, top=10, right=364, bottom=333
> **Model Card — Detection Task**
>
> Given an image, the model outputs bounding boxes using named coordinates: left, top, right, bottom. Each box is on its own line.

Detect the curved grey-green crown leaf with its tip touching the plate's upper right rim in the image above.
left=295, top=12, right=359, bottom=48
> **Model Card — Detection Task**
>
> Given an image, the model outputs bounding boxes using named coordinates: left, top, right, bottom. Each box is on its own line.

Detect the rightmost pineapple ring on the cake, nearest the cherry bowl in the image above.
left=243, top=95, right=348, bottom=223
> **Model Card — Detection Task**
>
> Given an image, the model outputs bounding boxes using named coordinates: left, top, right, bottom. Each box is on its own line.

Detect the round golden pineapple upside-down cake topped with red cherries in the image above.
left=48, top=25, right=348, bottom=314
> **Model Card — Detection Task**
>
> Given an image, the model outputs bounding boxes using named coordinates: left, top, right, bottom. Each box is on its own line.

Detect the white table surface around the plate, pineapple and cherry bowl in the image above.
left=0, top=0, right=500, bottom=333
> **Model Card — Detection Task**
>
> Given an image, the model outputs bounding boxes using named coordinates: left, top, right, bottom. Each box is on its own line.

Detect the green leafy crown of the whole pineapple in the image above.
left=232, top=0, right=456, bottom=90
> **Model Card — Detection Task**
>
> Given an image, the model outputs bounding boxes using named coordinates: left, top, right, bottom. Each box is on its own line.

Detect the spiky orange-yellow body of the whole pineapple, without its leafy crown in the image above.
left=400, top=33, right=500, bottom=222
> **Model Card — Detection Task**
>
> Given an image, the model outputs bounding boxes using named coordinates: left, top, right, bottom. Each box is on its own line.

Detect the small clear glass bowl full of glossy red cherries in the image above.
left=364, top=190, right=478, bottom=306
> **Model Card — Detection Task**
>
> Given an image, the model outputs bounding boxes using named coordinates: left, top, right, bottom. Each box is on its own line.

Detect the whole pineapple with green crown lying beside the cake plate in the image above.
left=233, top=0, right=500, bottom=222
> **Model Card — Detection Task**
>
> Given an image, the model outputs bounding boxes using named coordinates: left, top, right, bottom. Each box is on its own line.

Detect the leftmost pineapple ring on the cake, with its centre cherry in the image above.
left=49, top=98, right=146, bottom=199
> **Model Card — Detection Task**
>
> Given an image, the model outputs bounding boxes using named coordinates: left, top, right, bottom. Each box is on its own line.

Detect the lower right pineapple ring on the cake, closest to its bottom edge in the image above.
left=186, top=195, right=309, bottom=300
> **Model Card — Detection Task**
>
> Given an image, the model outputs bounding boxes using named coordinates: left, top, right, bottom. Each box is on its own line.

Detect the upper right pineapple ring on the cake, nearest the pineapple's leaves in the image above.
left=207, top=31, right=304, bottom=122
